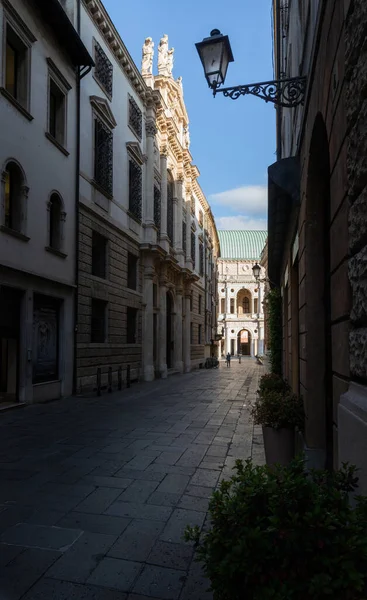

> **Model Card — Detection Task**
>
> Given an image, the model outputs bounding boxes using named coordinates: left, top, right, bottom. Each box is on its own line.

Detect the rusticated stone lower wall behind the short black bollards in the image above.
left=77, top=208, right=142, bottom=392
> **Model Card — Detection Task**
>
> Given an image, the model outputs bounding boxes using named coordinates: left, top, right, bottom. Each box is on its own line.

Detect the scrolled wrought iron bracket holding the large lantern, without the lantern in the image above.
left=212, top=77, right=307, bottom=108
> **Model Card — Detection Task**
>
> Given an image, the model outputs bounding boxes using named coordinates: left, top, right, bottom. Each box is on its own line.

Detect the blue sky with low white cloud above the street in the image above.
left=104, top=0, right=276, bottom=229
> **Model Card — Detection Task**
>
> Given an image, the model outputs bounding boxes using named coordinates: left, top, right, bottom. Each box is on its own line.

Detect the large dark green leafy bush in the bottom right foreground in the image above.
left=185, top=459, right=367, bottom=600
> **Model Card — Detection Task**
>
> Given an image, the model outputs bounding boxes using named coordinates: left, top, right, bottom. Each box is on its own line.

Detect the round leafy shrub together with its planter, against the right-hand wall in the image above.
left=251, top=375, right=305, bottom=465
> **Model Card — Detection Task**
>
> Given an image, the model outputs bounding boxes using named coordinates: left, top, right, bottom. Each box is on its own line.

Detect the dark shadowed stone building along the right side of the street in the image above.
left=268, top=0, right=367, bottom=492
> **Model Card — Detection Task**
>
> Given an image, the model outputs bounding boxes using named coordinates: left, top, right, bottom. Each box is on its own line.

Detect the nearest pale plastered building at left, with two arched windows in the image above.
left=0, top=0, right=92, bottom=405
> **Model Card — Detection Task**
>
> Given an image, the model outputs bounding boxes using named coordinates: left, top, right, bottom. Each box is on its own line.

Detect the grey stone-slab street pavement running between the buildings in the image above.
left=0, top=360, right=264, bottom=600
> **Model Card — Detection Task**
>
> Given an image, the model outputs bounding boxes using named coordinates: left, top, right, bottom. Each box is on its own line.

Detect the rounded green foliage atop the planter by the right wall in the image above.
left=250, top=389, right=305, bottom=431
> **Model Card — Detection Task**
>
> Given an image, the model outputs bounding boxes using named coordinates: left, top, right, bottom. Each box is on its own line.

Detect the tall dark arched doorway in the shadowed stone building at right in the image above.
left=300, top=114, right=333, bottom=469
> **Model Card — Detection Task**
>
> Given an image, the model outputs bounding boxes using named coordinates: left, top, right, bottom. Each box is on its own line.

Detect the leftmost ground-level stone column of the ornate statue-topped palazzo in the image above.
left=143, top=261, right=155, bottom=381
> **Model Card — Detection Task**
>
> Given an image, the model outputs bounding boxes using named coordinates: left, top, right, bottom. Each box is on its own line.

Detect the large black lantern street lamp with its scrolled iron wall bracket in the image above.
left=195, top=29, right=306, bottom=108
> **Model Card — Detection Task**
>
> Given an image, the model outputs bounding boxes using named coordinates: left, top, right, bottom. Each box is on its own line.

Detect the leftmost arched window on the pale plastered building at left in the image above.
left=3, top=162, right=28, bottom=232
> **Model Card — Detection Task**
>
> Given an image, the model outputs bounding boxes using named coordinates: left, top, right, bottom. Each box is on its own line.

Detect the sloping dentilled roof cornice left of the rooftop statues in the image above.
left=83, top=0, right=152, bottom=104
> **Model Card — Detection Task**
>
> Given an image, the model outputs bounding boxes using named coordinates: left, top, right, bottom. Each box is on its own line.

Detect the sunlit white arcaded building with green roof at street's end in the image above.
left=217, top=230, right=267, bottom=357
